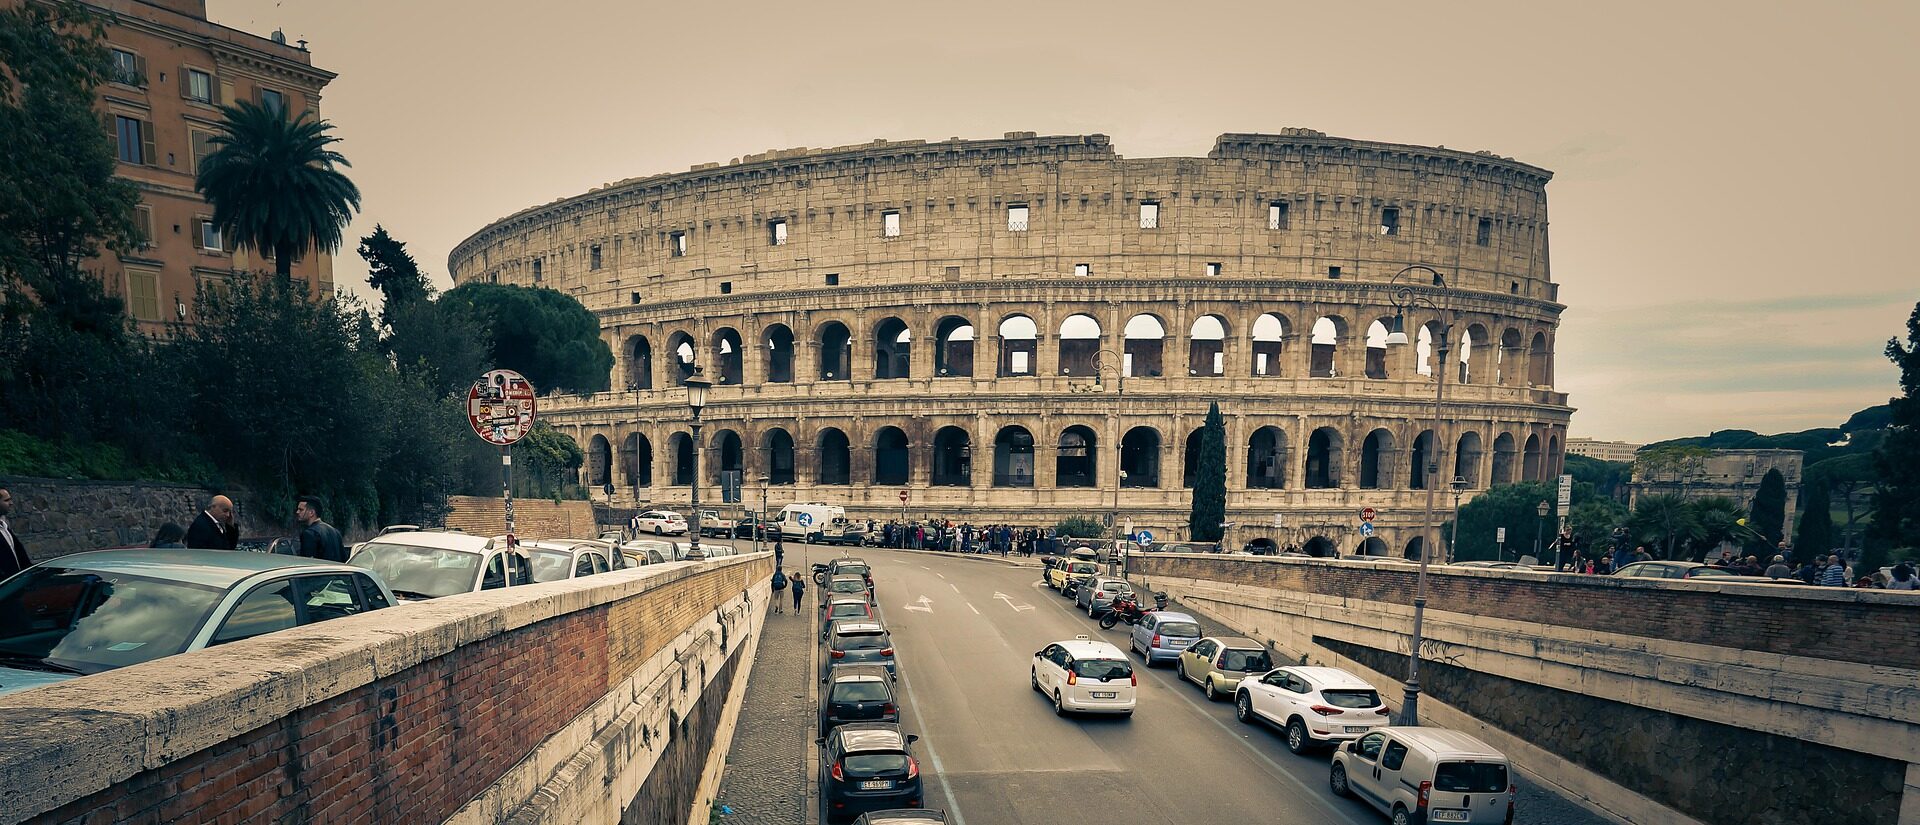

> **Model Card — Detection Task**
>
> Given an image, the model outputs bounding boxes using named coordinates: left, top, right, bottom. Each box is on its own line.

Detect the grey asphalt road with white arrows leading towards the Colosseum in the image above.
left=833, top=549, right=1384, bottom=825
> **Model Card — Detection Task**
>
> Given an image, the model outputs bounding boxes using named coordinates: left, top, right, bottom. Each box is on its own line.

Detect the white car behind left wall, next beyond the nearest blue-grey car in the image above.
left=348, top=530, right=532, bottom=601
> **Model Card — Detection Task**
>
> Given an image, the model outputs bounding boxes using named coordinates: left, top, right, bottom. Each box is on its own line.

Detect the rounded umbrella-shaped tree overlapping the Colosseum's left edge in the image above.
left=436, top=282, right=612, bottom=393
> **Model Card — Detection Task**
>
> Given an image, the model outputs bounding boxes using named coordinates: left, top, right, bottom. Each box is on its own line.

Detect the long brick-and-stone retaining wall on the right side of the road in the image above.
left=1129, top=554, right=1920, bottom=825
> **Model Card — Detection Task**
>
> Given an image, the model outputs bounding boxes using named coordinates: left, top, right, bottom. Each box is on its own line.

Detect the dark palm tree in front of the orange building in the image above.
left=194, top=102, right=359, bottom=278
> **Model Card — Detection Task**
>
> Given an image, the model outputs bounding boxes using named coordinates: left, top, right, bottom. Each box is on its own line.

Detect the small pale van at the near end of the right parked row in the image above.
left=1327, top=727, right=1519, bottom=825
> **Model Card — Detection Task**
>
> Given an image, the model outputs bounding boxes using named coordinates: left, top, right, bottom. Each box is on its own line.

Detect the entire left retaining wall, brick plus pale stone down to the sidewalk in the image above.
left=0, top=554, right=772, bottom=825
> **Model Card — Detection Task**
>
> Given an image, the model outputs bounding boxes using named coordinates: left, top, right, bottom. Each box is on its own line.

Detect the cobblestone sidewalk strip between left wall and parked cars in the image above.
left=718, top=583, right=816, bottom=825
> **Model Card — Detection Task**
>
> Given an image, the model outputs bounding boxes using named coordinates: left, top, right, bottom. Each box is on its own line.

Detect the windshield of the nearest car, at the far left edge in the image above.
left=0, top=564, right=227, bottom=673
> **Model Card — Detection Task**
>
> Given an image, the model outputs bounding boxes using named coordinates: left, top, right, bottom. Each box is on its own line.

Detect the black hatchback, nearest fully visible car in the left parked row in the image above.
left=816, top=723, right=922, bottom=821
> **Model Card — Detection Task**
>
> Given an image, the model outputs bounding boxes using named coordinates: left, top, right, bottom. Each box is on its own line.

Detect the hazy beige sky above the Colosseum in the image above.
left=207, top=0, right=1920, bottom=441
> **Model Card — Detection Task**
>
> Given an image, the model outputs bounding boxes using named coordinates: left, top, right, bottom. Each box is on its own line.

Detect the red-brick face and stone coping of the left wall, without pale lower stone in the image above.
left=0, top=556, right=772, bottom=825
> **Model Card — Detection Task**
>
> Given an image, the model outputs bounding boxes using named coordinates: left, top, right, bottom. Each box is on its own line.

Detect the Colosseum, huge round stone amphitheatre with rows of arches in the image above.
left=447, top=129, right=1572, bottom=554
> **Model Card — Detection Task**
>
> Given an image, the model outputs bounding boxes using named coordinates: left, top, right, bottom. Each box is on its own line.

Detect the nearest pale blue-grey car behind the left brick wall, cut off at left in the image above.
left=0, top=549, right=394, bottom=695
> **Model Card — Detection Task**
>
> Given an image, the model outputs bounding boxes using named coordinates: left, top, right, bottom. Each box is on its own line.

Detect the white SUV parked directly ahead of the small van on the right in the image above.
left=1233, top=668, right=1388, bottom=754
